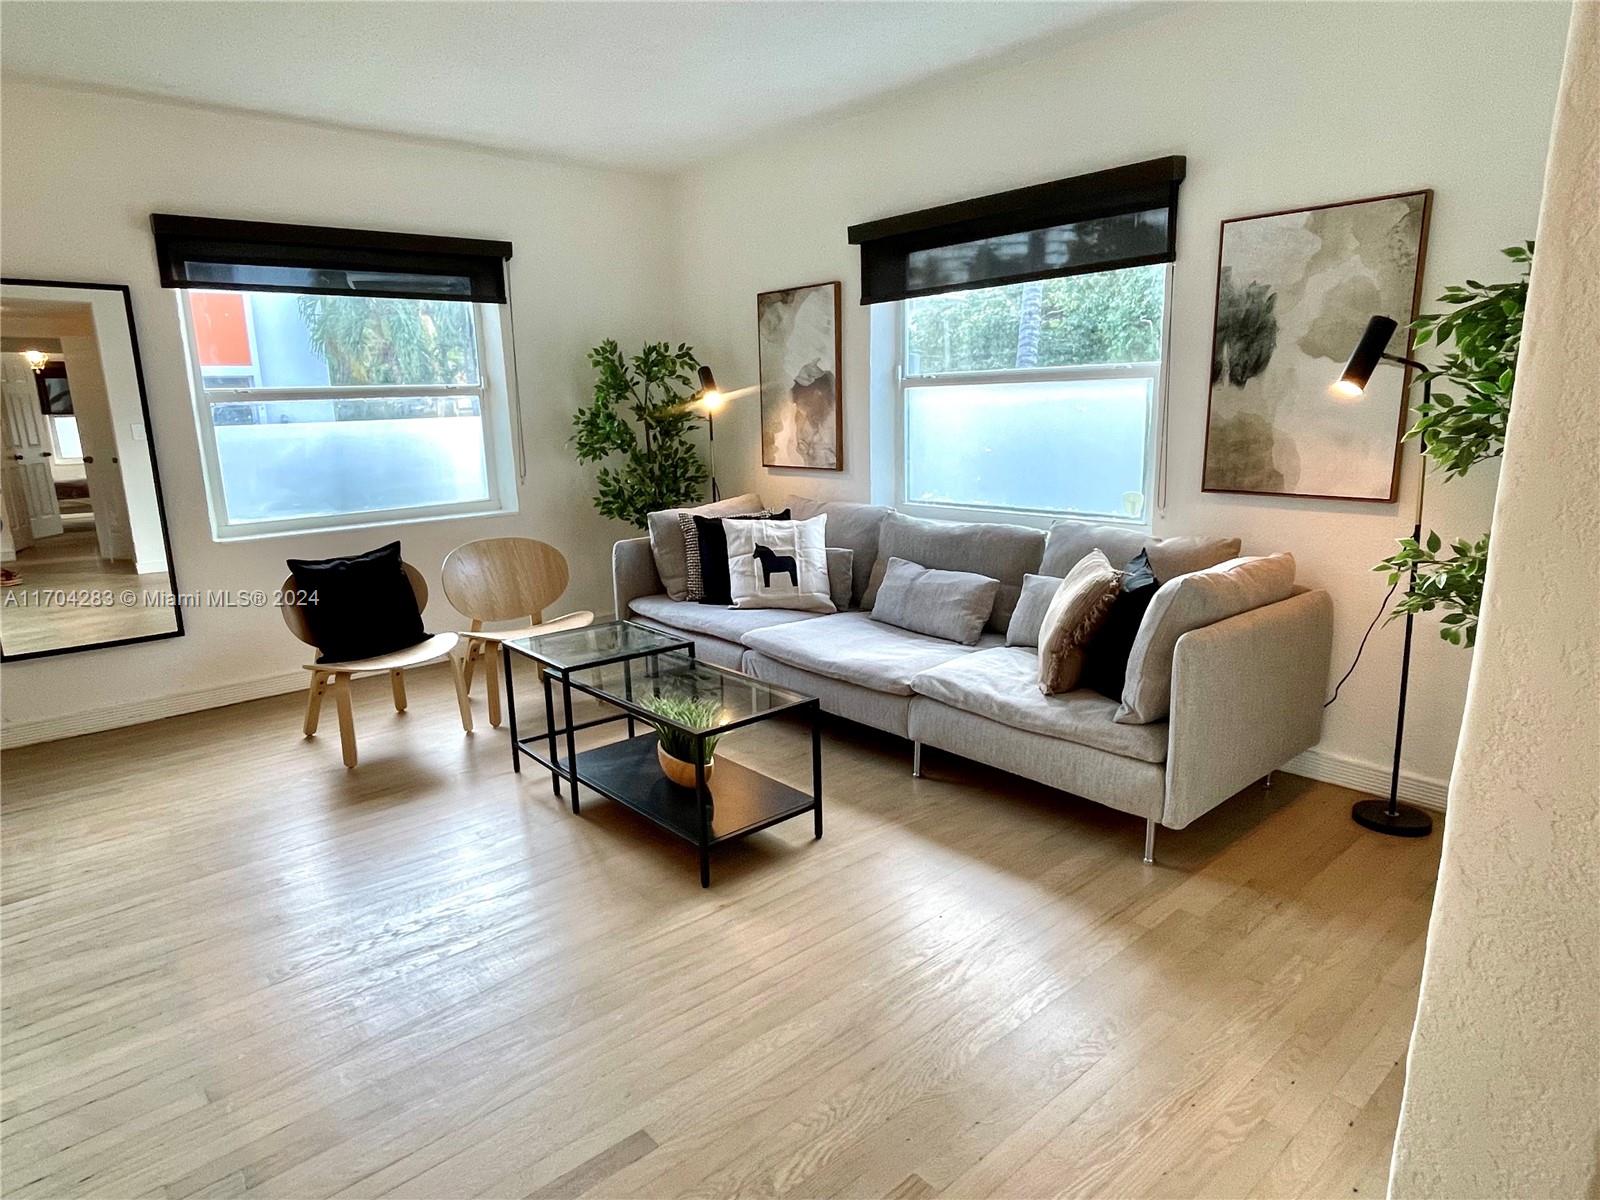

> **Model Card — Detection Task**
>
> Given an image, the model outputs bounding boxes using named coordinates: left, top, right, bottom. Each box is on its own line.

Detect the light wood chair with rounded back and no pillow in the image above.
left=440, top=538, right=595, bottom=728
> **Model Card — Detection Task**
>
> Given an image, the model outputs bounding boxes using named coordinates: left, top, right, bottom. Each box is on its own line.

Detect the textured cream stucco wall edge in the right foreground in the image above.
left=1389, top=0, right=1600, bottom=1200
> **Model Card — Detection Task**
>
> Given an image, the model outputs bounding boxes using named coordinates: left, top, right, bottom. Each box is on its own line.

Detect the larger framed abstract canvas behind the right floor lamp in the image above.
left=1202, top=190, right=1434, bottom=502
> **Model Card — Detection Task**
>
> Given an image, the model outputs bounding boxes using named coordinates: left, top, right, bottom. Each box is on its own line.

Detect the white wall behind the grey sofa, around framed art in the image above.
left=675, top=3, right=1566, bottom=802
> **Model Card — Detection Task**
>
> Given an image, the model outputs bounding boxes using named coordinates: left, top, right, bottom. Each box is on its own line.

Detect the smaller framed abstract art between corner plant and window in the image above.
left=755, top=282, right=845, bottom=470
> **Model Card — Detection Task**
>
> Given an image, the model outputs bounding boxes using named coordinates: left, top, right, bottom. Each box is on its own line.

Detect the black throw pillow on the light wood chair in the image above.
left=288, top=542, right=427, bottom=662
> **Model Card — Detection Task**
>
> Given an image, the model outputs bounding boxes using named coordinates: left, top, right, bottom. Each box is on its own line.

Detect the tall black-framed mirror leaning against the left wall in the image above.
left=0, top=278, right=184, bottom=661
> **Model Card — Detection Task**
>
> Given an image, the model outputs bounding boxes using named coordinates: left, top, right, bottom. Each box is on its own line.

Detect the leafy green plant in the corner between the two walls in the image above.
left=571, top=338, right=707, bottom=530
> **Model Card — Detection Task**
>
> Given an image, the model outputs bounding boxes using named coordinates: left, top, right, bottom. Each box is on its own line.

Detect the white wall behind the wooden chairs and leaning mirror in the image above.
left=0, top=83, right=670, bottom=742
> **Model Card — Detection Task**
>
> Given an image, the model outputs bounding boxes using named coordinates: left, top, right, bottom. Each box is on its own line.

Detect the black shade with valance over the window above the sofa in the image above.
left=850, top=155, right=1184, bottom=304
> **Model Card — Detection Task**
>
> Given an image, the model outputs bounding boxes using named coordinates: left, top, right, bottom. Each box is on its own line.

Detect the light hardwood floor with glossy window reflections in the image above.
left=0, top=669, right=1438, bottom=1200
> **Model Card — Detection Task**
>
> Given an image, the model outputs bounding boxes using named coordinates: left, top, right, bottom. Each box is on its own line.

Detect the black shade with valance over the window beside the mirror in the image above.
left=150, top=213, right=510, bottom=304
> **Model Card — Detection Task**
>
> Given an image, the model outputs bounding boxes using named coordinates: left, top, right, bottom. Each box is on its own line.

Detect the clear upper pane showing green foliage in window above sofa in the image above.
left=906, top=267, right=1165, bottom=374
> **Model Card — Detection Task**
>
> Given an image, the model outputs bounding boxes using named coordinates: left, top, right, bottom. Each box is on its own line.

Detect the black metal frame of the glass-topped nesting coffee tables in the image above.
left=501, top=640, right=822, bottom=888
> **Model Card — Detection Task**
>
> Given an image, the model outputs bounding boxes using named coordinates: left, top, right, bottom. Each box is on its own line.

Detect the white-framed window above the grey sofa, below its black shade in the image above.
left=898, top=264, right=1168, bottom=522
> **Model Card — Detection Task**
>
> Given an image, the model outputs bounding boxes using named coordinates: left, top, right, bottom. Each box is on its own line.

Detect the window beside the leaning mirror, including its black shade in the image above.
left=155, top=218, right=517, bottom=539
